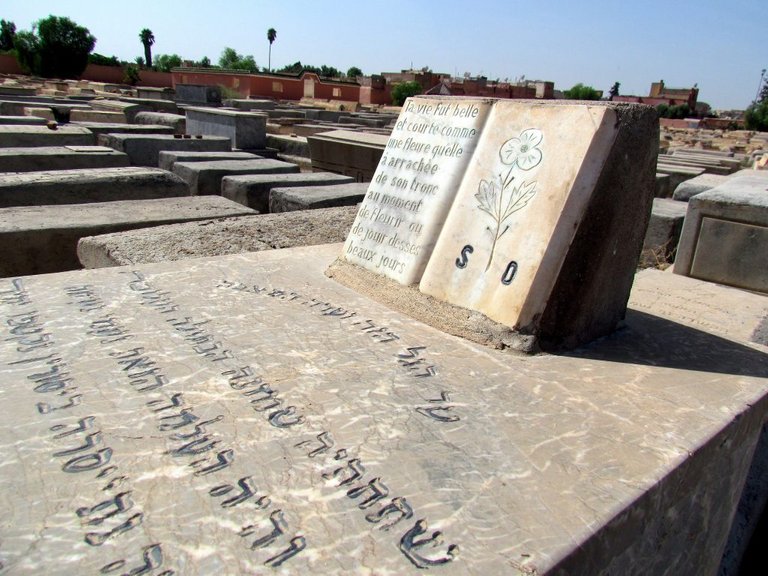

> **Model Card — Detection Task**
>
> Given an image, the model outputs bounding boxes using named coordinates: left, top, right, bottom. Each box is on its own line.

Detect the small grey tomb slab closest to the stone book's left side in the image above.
left=269, top=182, right=368, bottom=212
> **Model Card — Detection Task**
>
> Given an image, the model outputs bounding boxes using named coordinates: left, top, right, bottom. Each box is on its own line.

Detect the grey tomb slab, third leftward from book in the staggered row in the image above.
left=173, top=158, right=299, bottom=197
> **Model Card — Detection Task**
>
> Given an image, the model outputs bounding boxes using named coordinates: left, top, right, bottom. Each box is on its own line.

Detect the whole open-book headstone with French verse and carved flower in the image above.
left=338, top=97, right=658, bottom=349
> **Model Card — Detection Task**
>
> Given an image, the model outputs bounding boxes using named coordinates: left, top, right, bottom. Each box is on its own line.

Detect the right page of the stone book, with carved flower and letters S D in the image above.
left=420, top=101, right=617, bottom=328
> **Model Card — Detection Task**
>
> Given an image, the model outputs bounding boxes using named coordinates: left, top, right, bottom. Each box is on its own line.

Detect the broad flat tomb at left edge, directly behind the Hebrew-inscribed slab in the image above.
left=0, top=197, right=254, bottom=277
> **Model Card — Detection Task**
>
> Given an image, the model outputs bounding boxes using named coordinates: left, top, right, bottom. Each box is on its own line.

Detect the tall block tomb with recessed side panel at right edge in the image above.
left=674, top=175, right=768, bottom=293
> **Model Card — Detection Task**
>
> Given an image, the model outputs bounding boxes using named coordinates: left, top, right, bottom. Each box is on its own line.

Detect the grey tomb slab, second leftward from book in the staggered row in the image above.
left=221, top=171, right=354, bottom=213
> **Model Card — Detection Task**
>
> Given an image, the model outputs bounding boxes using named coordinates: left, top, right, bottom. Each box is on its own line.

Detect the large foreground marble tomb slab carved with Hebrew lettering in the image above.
left=0, top=245, right=768, bottom=576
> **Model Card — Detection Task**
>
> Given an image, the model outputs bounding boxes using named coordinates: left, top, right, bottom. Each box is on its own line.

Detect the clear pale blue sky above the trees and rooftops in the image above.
left=0, top=0, right=768, bottom=108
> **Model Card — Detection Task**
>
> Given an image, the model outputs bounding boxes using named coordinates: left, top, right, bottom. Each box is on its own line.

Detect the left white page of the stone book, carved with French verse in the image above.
left=343, top=97, right=491, bottom=285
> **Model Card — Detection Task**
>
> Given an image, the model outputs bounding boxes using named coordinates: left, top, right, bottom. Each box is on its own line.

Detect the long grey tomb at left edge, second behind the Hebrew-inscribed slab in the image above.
left=0, top=166, right=189, bottom=208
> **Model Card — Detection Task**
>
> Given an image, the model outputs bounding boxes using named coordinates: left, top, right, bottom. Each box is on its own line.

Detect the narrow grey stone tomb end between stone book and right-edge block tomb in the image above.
left=640, top=198, right=688, bottom=268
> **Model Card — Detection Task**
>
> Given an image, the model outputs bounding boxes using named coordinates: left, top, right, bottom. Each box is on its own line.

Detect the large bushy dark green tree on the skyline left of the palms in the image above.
left=13, top=16, right=96, bottom=78
